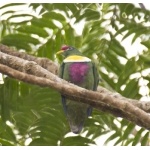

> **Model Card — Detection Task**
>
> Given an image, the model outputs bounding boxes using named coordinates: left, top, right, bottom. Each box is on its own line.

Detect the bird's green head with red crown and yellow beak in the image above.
left=56, top=45, right=81, bottom=57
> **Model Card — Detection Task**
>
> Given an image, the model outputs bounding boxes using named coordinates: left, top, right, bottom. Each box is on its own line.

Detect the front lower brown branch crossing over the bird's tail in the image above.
left=0, top=64, right=150, bottom=129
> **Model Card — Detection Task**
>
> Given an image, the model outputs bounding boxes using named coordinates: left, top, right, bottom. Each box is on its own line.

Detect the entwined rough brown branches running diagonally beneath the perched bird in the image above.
left=0, top=45, right=150, bottom=130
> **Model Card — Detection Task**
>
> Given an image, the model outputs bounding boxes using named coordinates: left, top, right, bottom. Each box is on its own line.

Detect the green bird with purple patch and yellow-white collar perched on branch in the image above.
left=56, top=45, right=99, bottom=134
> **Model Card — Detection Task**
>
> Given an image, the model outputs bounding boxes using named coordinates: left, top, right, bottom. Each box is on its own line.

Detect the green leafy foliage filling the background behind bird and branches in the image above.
left=0, top=3, right=150, bottom=145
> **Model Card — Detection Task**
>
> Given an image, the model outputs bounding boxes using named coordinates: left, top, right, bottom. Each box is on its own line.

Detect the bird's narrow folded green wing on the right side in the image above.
left=93, top=63, right=99, bottom=91
